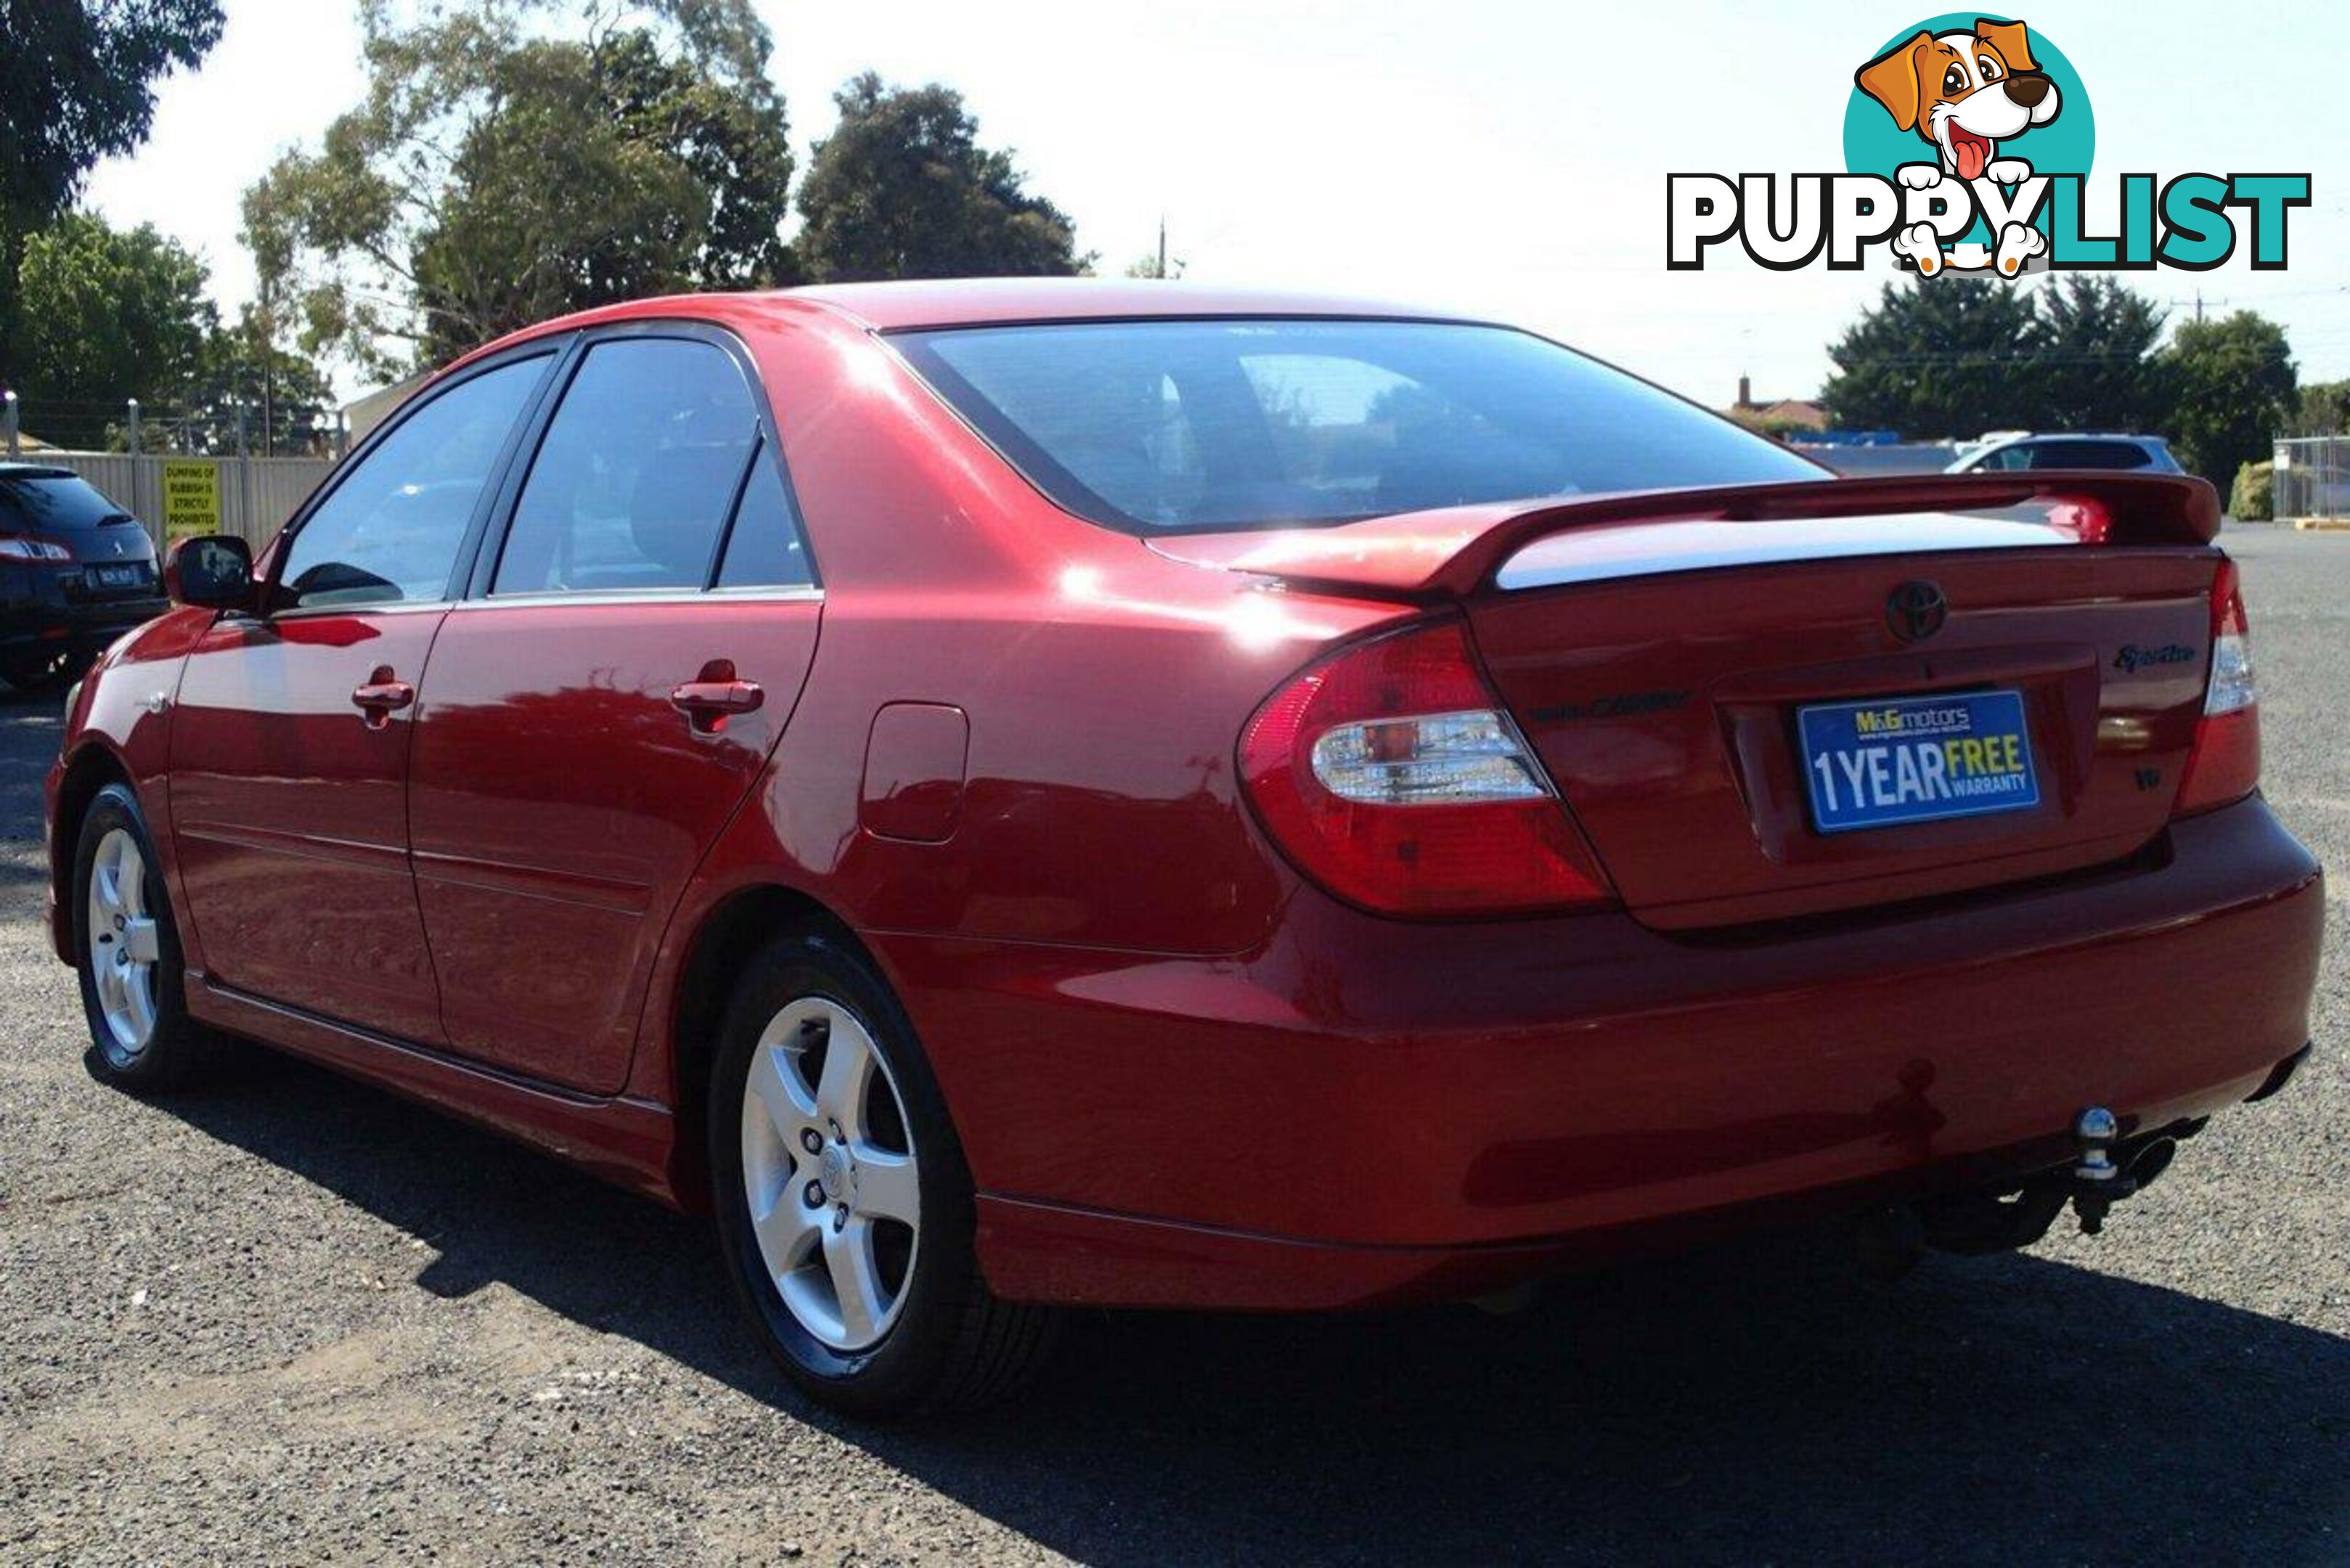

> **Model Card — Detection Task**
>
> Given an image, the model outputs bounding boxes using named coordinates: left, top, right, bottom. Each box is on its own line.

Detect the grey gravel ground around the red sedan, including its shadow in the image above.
left=0, top=529, right=2350, bottom=1564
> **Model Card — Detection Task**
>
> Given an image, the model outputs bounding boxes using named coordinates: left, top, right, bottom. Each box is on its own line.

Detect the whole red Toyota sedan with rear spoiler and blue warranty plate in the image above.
left=49, top=282, right=2322, bottom=1413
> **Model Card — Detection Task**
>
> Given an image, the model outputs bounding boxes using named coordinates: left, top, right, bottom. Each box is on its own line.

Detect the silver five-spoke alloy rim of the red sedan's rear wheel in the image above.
left=743, top=997, right=921, bottom=1354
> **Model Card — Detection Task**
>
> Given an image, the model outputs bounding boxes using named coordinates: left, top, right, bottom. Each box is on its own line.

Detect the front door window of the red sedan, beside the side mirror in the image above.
left=277, top=355, right=547, bottom=607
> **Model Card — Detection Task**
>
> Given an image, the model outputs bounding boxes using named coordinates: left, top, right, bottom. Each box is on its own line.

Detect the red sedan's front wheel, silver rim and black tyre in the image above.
left=73, top=783, right=214, bottom=1091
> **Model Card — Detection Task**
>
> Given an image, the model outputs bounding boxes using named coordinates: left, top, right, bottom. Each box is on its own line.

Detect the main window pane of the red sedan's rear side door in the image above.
left=491, top=338, right=759, bottom=592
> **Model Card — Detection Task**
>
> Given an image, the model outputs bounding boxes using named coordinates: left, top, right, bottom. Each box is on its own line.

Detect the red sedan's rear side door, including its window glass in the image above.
left=409, top=327, right=820, bottom=1093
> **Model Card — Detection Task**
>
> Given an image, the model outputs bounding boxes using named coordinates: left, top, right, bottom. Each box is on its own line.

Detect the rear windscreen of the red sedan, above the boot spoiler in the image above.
left=891, top=319, right=1826, bottom=534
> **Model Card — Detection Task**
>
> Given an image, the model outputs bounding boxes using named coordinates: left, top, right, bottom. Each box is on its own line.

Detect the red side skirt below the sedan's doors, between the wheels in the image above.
left=188, top=973, right=701, bottom=1209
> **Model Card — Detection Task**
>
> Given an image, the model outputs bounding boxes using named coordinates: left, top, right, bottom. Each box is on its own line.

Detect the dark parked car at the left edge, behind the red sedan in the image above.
left=0, top=463, right=165, bottom=687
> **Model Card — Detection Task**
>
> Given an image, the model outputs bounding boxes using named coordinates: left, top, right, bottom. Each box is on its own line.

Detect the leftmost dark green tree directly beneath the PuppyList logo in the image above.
left=1819, top=277, right=2047, bottom=440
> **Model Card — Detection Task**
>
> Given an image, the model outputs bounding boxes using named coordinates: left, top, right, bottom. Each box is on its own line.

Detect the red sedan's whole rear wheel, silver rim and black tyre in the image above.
left=707, top=931, right=1058, bottom=1418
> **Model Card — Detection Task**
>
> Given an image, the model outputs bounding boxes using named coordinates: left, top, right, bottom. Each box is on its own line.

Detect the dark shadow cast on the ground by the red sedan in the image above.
left=151, top=1058, right=2350, bottom=1564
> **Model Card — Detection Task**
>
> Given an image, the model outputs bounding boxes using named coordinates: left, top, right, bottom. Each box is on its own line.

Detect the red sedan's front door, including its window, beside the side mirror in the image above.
left=171, top=348, right=555, bottom=1044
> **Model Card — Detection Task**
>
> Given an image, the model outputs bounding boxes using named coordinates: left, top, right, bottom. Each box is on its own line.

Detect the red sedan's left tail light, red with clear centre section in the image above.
left=1241, top=623, right=1612, bottom=915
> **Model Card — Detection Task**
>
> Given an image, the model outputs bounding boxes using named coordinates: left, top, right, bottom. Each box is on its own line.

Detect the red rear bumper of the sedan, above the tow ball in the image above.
left=870, top=799, right=2324, bottom=1307
